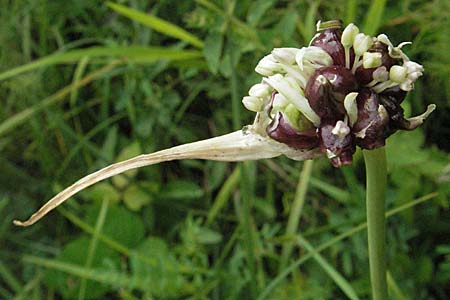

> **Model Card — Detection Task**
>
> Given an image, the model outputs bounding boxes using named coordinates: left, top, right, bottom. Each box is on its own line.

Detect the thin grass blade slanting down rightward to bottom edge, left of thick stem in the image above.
left=297, top=236, right=359, bottom=300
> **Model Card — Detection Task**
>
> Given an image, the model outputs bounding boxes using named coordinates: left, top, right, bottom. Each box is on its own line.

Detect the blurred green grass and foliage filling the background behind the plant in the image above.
left=0, top=0, right=450, bottom=300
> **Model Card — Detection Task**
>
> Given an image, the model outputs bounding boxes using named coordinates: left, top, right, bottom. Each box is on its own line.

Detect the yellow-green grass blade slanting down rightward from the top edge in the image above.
left=108, top=2, right=203, bottom=48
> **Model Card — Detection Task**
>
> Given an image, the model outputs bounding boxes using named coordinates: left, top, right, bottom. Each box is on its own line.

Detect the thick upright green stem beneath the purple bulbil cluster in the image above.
left=363, top=148, right=387, bottom=300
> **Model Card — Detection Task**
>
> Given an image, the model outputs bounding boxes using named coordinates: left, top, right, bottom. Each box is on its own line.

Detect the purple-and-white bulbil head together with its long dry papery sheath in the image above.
left=14, top=21, right=435, bottom=226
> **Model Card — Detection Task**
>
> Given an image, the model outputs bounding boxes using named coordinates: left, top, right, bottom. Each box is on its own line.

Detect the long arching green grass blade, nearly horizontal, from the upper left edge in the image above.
left=0, top=46, right=202, bottom=81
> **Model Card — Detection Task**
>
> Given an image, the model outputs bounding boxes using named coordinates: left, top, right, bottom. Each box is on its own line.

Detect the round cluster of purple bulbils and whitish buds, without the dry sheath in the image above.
left=242, top=21, right=435, bottom=167
